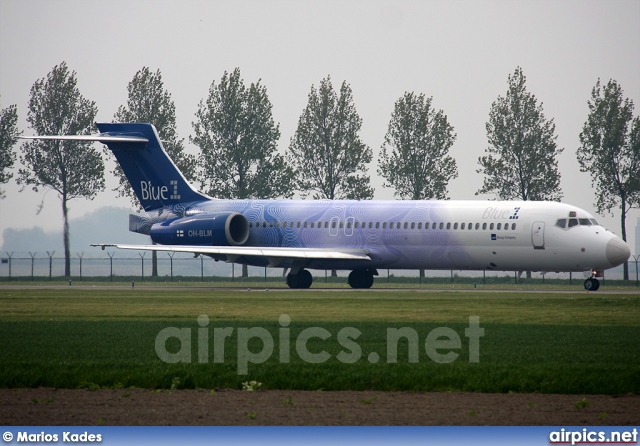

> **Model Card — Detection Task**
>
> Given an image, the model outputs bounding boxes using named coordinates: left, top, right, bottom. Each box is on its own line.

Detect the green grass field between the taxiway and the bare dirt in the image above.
left=0, top=287, right=640, bottom=394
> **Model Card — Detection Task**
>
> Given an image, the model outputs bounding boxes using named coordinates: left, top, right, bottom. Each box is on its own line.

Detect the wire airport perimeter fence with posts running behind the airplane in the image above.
left=0, top=251, right=640, bottom=287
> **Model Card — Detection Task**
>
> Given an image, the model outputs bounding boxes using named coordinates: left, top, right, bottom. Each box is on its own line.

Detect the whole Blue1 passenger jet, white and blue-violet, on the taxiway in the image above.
left=22, top=123, right=630, bottom=291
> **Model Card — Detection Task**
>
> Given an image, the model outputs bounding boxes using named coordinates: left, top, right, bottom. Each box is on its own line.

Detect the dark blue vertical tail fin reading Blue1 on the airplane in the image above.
left=96, top=123, right=210, bottom=211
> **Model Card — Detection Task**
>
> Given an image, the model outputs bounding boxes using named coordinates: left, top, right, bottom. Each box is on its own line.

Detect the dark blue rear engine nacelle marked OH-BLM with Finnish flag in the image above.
left=150, top=212, right=249, bottom=246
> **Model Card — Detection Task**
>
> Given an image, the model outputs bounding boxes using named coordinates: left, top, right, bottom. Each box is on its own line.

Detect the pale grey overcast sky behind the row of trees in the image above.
left=0, top=0, right=640, bottom=251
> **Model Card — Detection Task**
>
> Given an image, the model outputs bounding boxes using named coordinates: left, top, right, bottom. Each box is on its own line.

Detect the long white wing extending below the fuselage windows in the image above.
left=91, top=243, right=371, bottom=266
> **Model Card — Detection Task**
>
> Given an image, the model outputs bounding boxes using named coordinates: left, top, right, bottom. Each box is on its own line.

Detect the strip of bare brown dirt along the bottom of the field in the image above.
left=0, top=388, right=640, bottom=426
